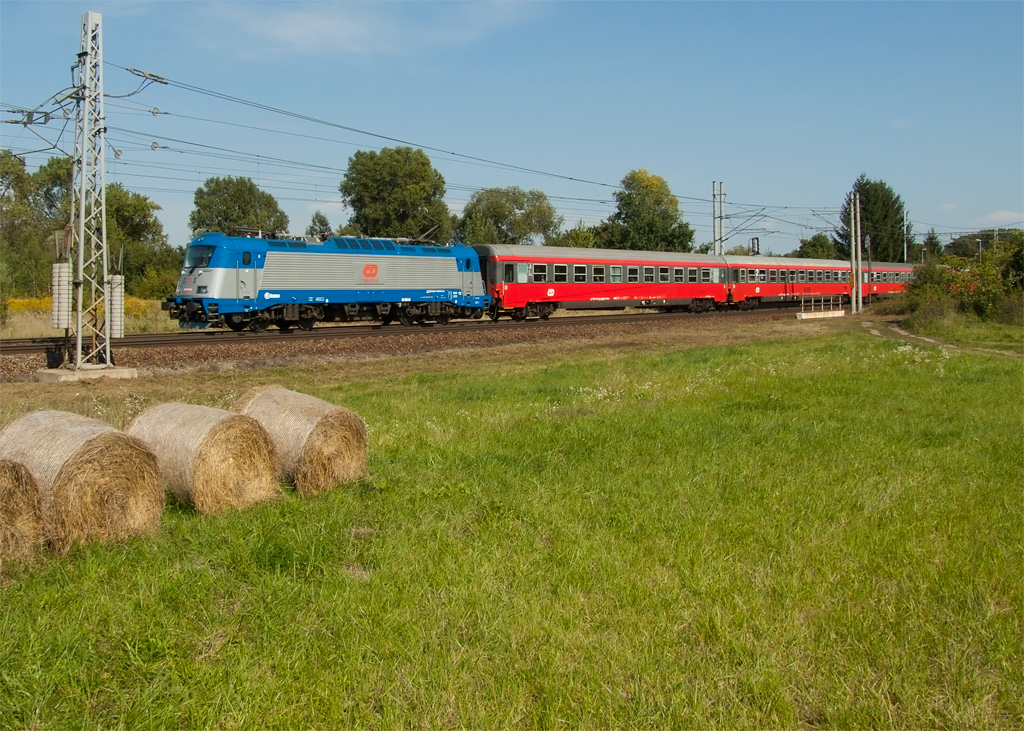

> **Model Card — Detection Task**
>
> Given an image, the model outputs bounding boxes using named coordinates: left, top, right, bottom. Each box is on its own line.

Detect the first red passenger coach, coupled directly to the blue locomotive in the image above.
left=473, top=245, right=729, bottom=319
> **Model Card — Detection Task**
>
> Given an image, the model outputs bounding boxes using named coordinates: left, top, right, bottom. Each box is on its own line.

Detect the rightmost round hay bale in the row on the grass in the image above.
left=236, top=386, right=368, bottom=498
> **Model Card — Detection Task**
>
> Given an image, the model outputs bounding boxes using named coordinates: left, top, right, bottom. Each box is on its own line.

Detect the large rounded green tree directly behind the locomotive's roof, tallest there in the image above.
left=338, top=146, right=454, bottom=242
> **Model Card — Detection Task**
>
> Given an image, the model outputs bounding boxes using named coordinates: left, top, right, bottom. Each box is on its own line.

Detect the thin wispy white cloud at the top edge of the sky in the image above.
left=211, top=2, right=539, bottom=57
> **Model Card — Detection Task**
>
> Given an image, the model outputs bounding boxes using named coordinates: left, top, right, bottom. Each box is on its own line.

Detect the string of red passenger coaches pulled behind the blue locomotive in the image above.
left=473, top=241, right=913, bottom=319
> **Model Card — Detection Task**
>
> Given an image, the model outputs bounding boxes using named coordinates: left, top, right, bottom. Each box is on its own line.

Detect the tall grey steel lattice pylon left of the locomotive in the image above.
left=68, top=12, right=112, bottom=370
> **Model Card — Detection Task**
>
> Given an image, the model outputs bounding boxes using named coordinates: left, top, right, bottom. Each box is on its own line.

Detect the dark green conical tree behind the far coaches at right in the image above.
left=833, top=174, right=913, bottom=261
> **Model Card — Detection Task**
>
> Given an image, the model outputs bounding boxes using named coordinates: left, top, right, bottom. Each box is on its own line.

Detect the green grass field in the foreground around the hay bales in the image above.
left=0, top=333, right=1024, bottom=729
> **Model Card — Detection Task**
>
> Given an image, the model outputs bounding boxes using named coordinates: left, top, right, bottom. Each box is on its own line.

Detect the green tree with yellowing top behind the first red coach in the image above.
left=596, top=169, right=693, bottom=252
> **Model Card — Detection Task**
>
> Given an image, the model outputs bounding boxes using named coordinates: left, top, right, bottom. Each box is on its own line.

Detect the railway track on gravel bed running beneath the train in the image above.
left=0, top=310, right=790, bottom=355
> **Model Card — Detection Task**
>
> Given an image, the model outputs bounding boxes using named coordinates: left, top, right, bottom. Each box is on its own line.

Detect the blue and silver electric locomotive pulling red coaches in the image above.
left=163, top=232, right=489, bottom=330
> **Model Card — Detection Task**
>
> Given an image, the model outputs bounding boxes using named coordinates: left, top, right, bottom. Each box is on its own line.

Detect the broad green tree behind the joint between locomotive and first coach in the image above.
left=456, top=186, right=563, bottom=245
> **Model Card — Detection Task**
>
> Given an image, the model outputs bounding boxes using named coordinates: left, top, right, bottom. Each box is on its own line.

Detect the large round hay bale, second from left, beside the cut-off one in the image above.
left=0, top=411, right=164, bottom=553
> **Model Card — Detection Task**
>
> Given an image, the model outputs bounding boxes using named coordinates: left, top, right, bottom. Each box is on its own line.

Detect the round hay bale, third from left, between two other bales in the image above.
left=128, top=403, right=282, bottom=515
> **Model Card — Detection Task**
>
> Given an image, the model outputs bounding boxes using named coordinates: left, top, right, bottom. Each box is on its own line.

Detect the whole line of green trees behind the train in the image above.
left=0, top=146, right=1021, bottom=321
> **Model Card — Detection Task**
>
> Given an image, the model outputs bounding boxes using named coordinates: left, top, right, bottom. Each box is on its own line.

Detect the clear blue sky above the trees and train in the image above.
left=0, top=0, right=1024, bottom=253
